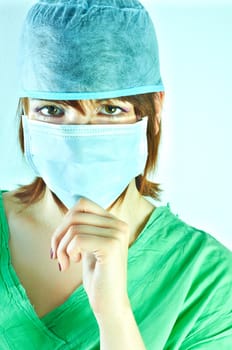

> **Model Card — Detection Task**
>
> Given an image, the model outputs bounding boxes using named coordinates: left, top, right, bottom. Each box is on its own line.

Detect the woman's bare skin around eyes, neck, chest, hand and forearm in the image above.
left=4, top=93, right=163, bottom=350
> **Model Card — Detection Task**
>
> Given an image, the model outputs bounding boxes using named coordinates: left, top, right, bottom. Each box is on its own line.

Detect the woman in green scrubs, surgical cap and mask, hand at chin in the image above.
left=0, top=0, right=232, bottom=350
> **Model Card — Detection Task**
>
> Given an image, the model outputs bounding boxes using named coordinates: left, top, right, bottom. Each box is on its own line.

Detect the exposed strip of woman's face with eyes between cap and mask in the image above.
left=27, top=99, right=138, bottom=124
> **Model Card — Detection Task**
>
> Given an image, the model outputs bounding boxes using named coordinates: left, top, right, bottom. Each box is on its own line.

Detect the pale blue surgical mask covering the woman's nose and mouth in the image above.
left=22, top=116, right=148, bottom=209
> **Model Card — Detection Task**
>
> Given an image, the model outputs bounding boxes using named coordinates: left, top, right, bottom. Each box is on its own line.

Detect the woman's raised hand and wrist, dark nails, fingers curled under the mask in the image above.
left=51, top=198, right=129, bottom=317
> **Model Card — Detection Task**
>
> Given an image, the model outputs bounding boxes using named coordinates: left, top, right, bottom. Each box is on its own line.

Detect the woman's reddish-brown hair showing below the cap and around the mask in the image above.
left=15, top=93, right=162, bottom=212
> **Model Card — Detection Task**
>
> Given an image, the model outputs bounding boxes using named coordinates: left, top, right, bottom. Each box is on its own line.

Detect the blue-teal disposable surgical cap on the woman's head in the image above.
left=19, top=0, right=164, bottom=100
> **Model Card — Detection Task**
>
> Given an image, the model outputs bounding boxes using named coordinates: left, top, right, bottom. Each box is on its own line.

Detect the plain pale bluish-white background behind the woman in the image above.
left=0, top=0, right=232, bottom=249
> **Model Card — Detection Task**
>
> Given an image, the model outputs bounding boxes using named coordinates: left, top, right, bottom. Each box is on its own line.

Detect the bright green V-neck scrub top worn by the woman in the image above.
left=0, top=193, right=232, bottom=350
